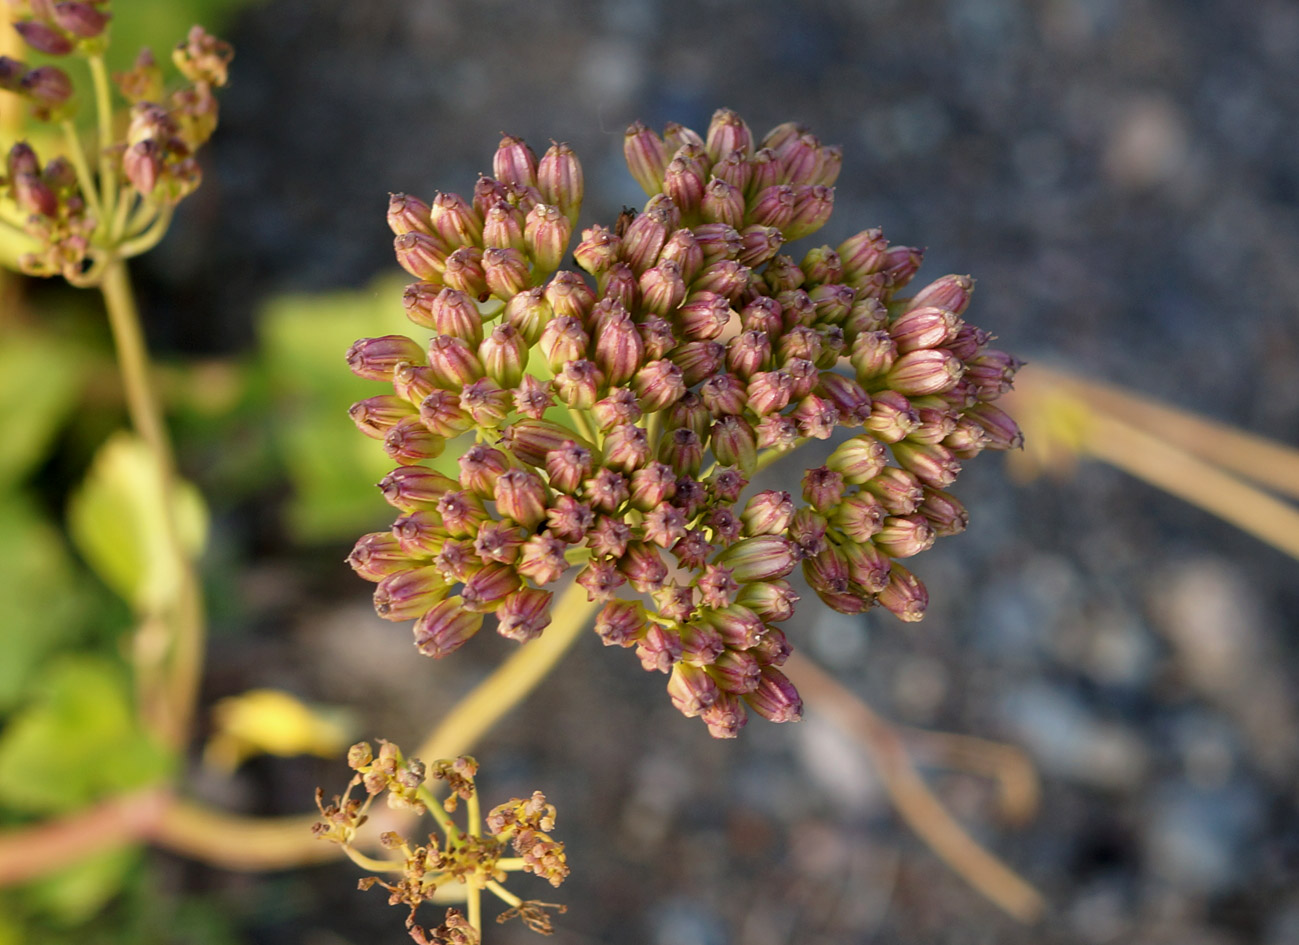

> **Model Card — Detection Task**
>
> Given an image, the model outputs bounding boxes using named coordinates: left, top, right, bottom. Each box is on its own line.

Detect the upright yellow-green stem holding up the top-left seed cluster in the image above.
left=100, top=259, right=204, bottom=747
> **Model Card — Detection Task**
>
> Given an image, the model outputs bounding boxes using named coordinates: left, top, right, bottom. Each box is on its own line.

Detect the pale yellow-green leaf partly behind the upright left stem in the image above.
left=68, top=433, right=208, bottom=614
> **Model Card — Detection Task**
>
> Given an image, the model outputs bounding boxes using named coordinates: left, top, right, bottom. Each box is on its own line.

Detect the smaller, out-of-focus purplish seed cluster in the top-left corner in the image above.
left=0, top=0, right=234, bottom=285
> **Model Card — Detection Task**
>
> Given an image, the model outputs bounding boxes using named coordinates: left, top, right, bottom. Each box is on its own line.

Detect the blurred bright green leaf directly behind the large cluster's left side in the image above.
left=260, top=278, right=455, bottom=542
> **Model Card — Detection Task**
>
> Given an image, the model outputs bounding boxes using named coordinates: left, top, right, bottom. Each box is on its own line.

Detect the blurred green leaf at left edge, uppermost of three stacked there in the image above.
left=0, top=331, right=86, bottom=489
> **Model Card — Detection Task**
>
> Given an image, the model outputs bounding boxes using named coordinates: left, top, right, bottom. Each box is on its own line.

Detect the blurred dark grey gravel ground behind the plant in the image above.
left=142, top=0, right=1299, bottom=945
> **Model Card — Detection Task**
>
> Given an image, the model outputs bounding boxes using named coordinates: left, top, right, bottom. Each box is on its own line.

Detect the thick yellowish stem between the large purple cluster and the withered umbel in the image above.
left=416, top=582, right=599, bottom=762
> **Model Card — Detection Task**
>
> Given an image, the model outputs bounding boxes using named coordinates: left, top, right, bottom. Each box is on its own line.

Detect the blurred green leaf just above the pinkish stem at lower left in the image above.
left=0, top=656, right=171, bottom=814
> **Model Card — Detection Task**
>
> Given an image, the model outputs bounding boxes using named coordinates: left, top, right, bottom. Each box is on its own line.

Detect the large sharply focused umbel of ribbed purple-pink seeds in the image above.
left=348, top=109, right=1020, bottom=737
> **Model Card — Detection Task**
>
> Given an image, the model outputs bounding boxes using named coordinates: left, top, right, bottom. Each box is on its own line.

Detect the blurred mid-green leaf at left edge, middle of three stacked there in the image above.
left=0, top=493, right=94, bottom=712
